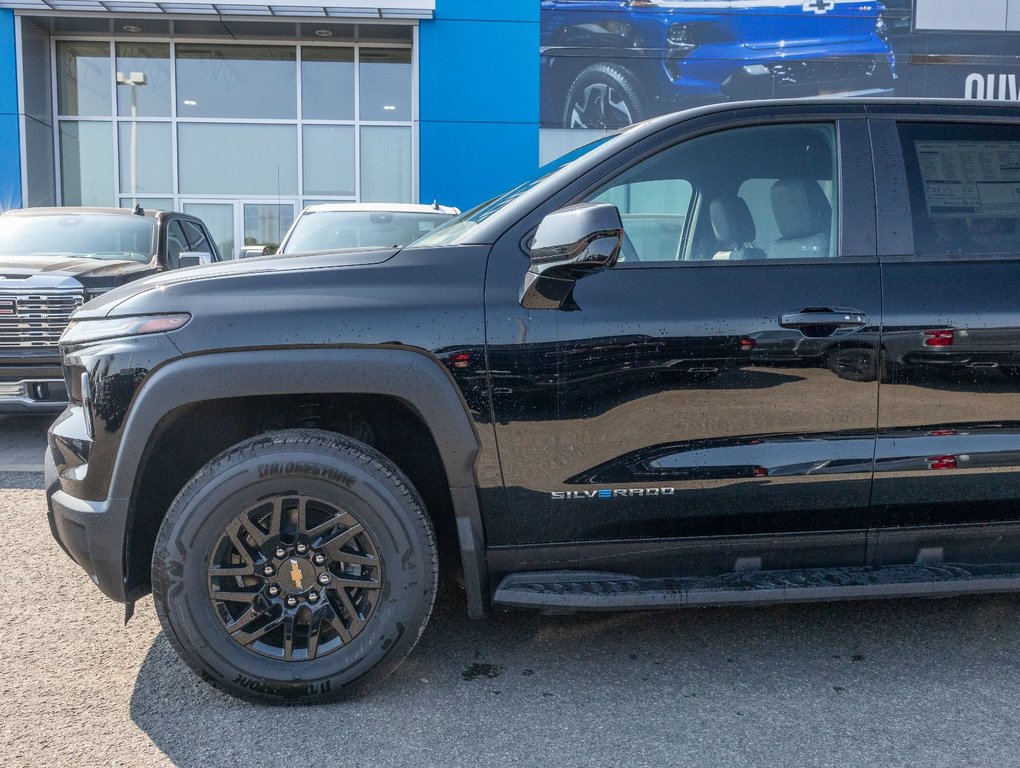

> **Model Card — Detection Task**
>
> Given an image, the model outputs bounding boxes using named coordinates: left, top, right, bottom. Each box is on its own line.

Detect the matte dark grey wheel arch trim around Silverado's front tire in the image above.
left=109, top=347, right=489, bottom=616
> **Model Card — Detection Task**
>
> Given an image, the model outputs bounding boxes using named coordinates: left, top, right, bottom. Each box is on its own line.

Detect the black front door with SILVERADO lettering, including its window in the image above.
left=487, top=118, right=881, bottom=564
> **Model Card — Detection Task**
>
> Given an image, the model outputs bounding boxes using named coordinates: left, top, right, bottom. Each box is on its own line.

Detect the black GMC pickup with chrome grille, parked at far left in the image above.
left=0, top=207, right=219, bottom=413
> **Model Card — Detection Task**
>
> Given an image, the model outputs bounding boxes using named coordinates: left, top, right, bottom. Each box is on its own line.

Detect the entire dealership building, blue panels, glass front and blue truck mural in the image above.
left=0, top=0, right=1020, bottom=254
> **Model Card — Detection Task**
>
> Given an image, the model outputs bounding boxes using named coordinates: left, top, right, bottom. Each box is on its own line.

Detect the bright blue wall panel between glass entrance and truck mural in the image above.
left=418, top=0, right=539, bottom=208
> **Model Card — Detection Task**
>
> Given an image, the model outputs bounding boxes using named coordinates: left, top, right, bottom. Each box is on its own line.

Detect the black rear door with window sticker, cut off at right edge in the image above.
left=872, top=121, right=1020, bottom=538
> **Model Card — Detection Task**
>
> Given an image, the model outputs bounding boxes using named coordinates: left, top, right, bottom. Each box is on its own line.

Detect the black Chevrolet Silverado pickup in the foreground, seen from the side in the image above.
left=47, top=99, right=1020, bottom=702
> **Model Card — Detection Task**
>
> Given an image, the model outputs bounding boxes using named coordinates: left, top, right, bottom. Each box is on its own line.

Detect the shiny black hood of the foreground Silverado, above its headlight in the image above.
left=75, top=248, right=399, bottom=318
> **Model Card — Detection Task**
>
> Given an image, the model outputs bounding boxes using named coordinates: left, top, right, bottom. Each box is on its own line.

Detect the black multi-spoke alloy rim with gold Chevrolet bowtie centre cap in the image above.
left=209, top=495, right=384, bottom=661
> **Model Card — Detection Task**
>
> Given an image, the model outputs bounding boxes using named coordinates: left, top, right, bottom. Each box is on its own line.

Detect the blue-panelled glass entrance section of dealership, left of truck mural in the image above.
left=0, top=0, right=539, bottom=254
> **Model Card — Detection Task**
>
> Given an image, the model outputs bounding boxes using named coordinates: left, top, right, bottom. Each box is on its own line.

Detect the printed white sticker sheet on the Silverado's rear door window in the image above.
left=915, top=142, right=1020, bottom=218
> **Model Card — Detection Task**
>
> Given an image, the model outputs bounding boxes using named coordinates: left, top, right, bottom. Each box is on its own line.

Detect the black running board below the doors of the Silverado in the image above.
left=493, top=563, right=1020, bottom=611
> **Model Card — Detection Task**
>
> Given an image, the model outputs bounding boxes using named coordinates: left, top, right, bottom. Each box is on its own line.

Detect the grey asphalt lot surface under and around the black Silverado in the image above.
left=0, top=473, right=1020, bottom=768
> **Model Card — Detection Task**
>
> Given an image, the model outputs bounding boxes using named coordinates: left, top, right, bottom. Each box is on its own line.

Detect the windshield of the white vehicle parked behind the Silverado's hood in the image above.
left=279, top=211, right=454, bottom=254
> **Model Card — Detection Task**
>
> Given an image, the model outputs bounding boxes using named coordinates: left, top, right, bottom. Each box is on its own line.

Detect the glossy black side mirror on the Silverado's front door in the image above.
left=520, top=203, right=623, bottom=310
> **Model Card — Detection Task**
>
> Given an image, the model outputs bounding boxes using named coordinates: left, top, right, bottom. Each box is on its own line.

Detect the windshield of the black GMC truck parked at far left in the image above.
left=0, top=213, right=155, bottom=262
